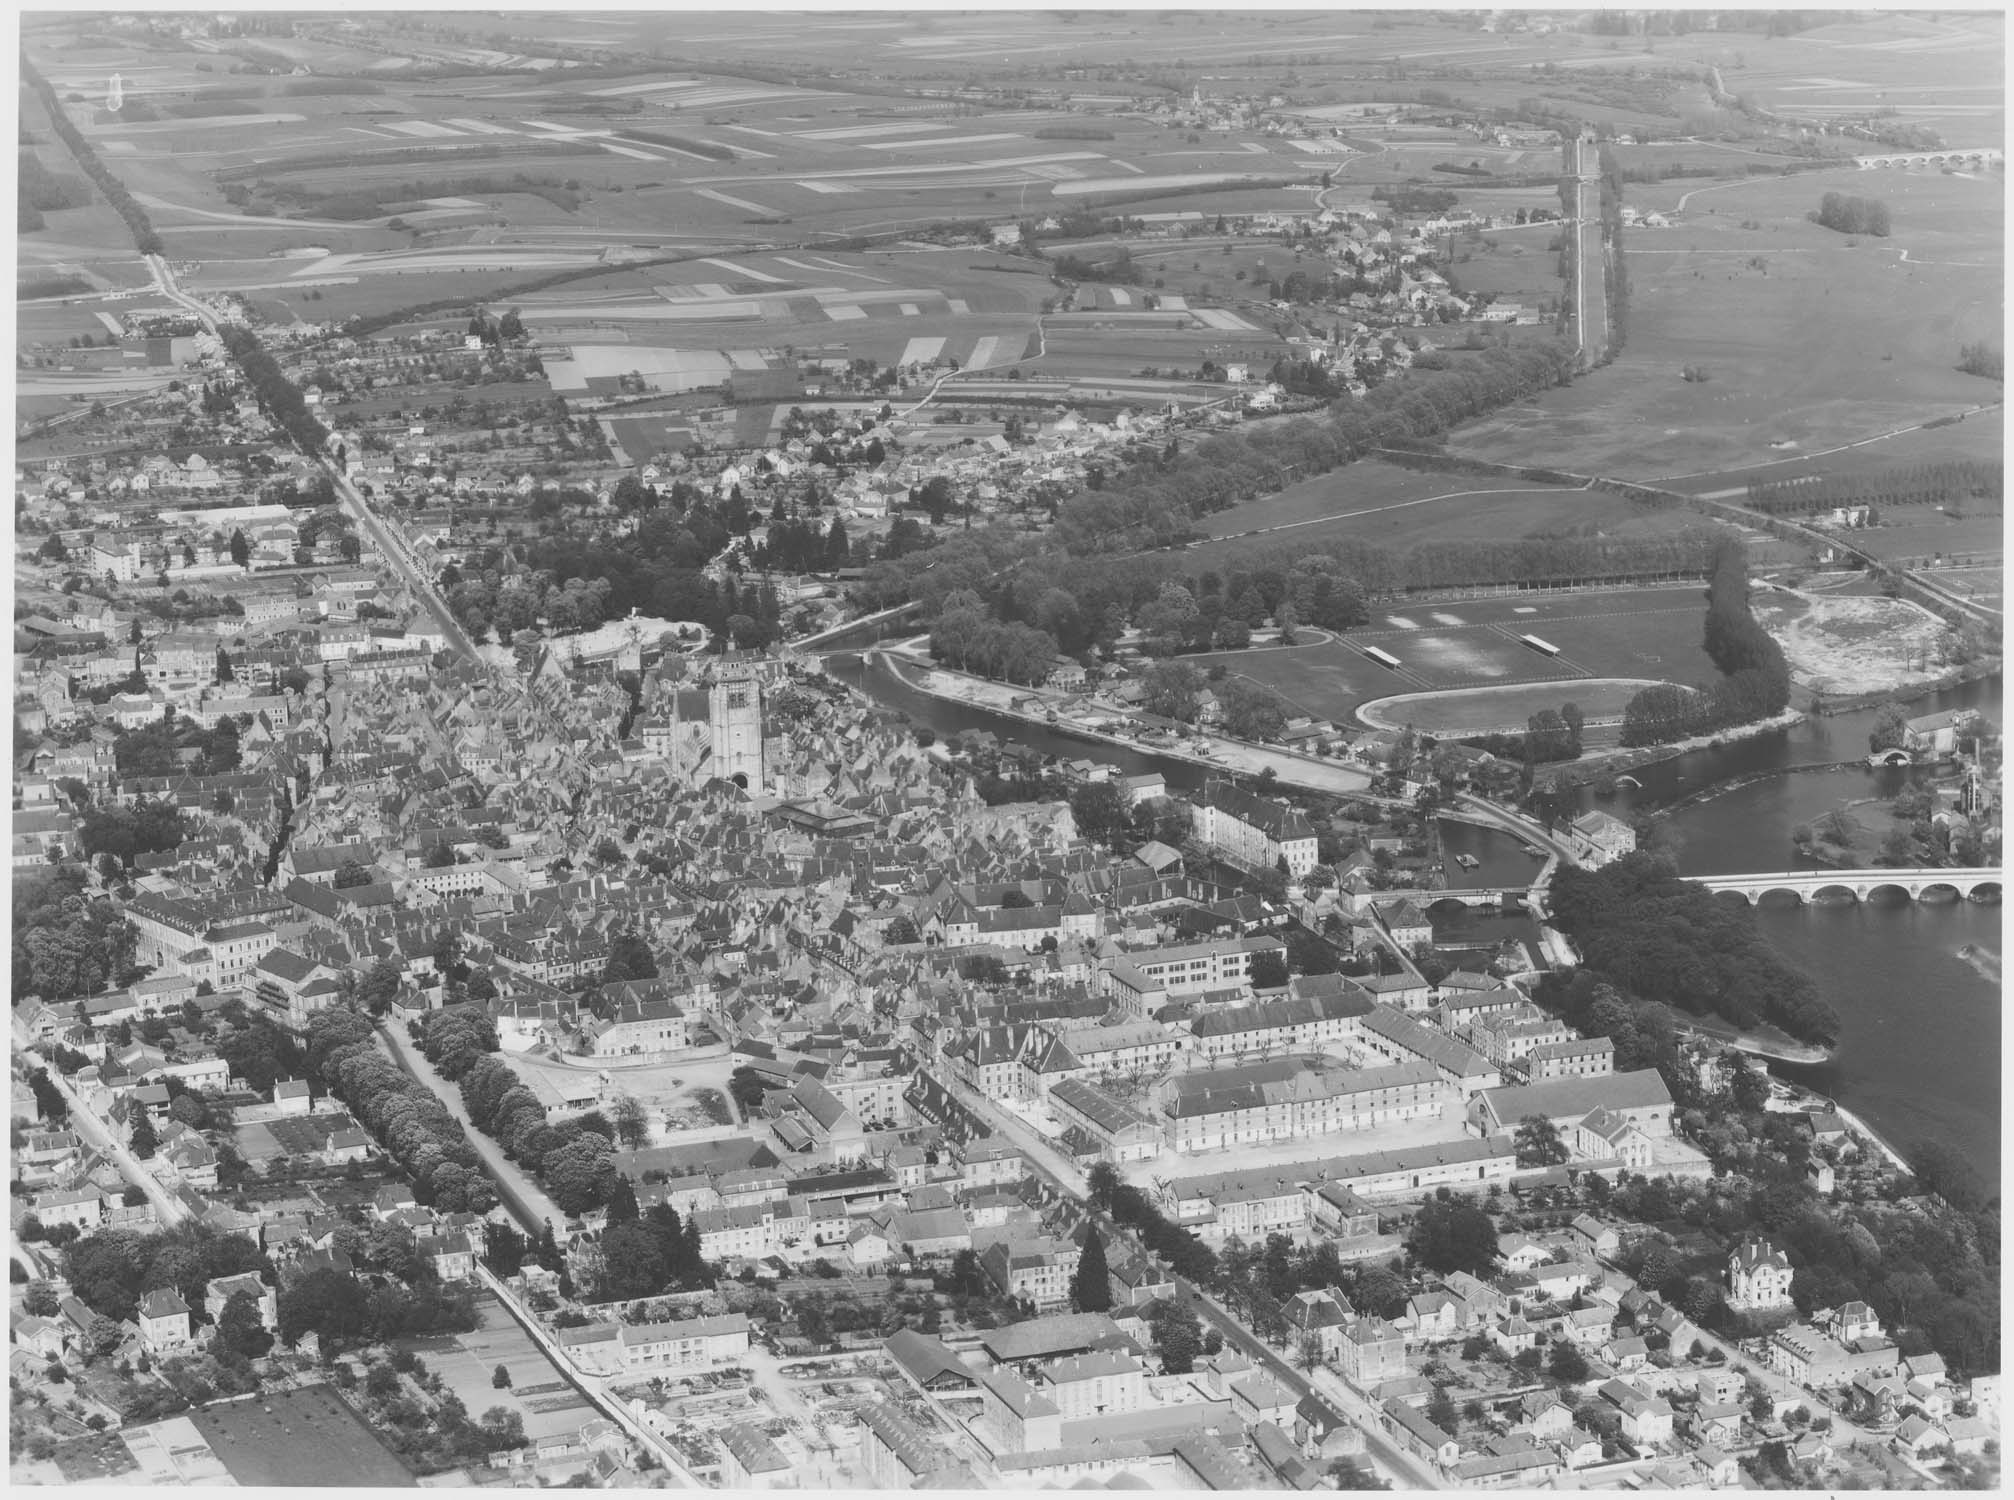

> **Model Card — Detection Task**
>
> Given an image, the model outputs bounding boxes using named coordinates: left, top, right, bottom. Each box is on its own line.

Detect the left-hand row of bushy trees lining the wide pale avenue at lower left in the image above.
left=308, top=1011, right=495, bottom=1214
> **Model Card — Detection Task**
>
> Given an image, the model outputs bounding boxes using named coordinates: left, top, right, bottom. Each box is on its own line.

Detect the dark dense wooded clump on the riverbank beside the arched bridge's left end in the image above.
left=1551, top=854, right=1839, bottom=1065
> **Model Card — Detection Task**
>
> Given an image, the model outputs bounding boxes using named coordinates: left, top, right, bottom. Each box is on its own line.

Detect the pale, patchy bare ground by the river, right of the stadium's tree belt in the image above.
left=1754, top=590, right=1952, bottom=693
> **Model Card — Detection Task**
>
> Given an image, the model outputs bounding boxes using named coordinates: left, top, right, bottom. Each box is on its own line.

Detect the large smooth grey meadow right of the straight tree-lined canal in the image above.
left=1454, top=169, right=2004, bottom=479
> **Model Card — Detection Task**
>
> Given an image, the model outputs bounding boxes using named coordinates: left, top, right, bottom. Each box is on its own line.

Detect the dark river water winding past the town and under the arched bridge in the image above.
left=830, top=656, right=2002, bottom=1182
